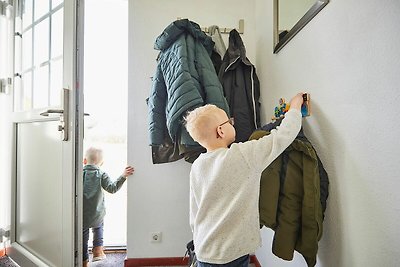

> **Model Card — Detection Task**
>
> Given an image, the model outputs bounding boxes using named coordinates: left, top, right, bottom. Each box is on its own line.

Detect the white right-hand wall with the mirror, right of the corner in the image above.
left=256, top=0, right=400, bottom=267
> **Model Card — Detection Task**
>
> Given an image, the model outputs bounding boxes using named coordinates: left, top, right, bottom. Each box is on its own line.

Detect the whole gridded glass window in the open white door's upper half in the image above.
left=14, top=0, right=64, bottom=111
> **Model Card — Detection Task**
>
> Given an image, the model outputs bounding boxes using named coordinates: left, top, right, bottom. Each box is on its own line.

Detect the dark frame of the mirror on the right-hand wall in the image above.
left=274, top=0, right=329, bottom=54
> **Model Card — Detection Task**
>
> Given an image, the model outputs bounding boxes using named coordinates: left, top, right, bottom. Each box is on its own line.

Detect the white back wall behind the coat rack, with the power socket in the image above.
left=127, top=0, right=256, bottom=258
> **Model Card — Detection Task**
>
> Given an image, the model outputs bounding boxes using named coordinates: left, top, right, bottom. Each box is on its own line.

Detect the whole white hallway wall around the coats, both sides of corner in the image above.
left=128, top=0, right=400, bottom=267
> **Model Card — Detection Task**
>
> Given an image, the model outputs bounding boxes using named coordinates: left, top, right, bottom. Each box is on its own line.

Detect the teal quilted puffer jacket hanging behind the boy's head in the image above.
left=148, top=19, right=229, bottom=146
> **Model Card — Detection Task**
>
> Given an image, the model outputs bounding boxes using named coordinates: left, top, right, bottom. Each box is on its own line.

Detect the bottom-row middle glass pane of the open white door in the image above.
left=33, top=65, right=49, bottom=108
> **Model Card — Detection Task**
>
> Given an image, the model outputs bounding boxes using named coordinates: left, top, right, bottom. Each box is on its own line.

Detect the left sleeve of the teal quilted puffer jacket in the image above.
left=147, top=63, right=167, bottom=145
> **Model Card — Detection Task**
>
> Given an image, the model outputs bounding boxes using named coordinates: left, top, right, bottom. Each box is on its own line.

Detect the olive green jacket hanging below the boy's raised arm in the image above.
left=250, top=130, right=328, bottom=266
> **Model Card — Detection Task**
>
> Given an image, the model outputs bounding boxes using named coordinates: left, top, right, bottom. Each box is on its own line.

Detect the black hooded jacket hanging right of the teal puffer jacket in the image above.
left=218, top=30, right=260, bottom=142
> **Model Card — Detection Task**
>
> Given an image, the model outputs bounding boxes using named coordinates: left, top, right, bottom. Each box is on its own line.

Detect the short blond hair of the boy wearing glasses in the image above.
left=185, top=104, right=221, bottom=143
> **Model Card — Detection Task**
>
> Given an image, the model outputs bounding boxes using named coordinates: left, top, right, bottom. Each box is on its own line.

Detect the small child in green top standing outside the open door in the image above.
left=82, top=147, right=134, bottom=267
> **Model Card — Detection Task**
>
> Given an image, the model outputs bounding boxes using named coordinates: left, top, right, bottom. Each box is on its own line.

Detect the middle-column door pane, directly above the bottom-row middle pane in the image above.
left=34, top=18, right=49, bottom=67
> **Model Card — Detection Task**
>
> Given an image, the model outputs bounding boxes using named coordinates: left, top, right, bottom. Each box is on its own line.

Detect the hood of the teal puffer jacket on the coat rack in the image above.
left=154, top=19, right=214, bottom=54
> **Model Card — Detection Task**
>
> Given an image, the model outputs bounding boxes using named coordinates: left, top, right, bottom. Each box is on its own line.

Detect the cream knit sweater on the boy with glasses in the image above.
left=190, top=109, right=301, bottom=264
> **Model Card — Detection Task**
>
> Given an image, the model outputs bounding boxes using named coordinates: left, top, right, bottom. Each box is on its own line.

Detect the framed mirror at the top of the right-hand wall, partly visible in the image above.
left=274, top=0, right=329, bottom=54
